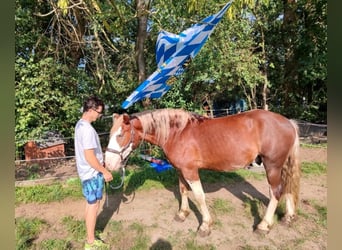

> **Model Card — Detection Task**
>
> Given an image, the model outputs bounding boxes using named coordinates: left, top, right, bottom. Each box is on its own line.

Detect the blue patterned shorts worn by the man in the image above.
left=82, top=173, right=104, bottom=204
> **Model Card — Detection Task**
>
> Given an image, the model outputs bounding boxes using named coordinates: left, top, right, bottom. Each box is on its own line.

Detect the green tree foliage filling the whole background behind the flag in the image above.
left=15, top=0, right=327, bottom=156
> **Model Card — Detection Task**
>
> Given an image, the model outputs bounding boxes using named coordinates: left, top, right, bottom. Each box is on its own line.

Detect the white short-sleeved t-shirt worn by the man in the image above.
left=74, top=119, right=103, bottom=181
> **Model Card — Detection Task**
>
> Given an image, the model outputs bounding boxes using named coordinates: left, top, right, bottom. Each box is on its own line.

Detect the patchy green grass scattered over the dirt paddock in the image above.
left=15, top=147, right=327, bottom=250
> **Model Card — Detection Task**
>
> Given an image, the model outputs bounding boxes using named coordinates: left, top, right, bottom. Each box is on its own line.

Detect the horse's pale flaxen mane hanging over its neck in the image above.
left=132, top=109, right=203, bottom=144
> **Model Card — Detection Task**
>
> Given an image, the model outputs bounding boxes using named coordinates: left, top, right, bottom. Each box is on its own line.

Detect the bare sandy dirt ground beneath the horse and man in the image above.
left=15, top=148, right=327, bottom=250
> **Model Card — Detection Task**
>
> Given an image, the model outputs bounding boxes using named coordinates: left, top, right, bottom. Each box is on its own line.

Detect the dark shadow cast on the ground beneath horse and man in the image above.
left=97, top=168, right=269, bottom=232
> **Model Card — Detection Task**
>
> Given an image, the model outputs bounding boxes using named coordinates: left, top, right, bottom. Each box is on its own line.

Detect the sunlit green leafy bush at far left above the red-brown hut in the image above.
left=15, top=58, right=81, bottom=146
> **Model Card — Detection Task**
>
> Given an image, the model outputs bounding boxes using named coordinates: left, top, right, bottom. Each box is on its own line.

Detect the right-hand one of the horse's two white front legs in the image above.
left=187, top=179, right=213, bottom=237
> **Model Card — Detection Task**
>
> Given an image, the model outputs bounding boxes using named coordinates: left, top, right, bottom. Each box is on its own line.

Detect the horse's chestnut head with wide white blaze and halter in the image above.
left=105, top=114, right=134, bottom=171
